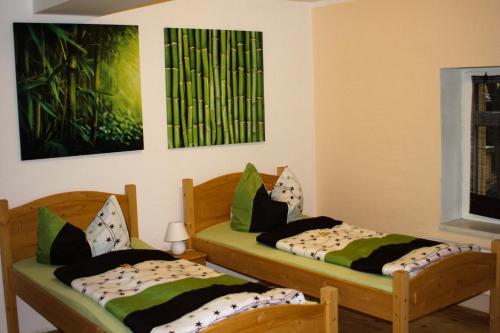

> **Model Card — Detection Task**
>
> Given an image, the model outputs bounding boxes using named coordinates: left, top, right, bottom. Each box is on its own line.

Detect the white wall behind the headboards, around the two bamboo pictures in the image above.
left=0, top=0, right=316, bottom=332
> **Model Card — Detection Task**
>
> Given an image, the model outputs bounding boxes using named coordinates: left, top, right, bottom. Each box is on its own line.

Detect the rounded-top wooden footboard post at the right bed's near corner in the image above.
left=392, top=271, right=410, bottom=333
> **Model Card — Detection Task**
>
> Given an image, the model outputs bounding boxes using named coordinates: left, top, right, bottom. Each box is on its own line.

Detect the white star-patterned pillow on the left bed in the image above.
left=85, top=195, right=130, bottom=257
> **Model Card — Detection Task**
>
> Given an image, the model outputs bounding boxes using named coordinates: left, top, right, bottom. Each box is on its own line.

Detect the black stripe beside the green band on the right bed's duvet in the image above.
left=351, top=238, right=440, bottom=274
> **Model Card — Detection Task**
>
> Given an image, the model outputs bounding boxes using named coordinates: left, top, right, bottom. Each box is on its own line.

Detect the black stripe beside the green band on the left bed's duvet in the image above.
left=123, top=282, right=269, bottom=333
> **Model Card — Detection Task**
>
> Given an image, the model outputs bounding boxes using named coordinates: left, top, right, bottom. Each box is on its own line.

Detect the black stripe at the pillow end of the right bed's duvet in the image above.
left=257, top=216, right=342, bottom=247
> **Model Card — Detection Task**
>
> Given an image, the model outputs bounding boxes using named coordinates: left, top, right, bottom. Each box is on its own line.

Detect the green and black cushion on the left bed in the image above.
left=36, top=207, right=92, bottom=265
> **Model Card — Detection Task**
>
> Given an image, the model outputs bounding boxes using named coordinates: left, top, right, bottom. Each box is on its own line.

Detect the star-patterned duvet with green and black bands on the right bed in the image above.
left=257, top=216, right=481, bottom=276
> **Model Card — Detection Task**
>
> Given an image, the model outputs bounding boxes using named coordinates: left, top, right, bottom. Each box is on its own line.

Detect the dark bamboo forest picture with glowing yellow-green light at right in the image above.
left=14, top=23, right=143, bottom=160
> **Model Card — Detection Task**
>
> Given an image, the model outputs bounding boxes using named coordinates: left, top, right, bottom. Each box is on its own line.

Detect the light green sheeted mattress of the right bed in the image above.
left=196, top=222, right=392, bottom=292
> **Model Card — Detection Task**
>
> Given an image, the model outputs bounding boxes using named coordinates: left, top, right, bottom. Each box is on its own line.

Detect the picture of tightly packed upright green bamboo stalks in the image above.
left=164, top=28, right=265, bottom=148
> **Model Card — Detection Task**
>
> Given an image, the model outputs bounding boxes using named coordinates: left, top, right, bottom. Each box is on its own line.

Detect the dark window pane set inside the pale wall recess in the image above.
left=469, top=74, right=500, bottom=219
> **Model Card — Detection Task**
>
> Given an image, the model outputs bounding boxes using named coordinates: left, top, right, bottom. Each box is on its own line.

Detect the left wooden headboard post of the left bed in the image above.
left=0, top=200, right=19, bottom=333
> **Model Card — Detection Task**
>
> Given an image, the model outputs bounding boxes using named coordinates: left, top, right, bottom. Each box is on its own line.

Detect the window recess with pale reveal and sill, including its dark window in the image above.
left=440, top=67, right=500, bottom=231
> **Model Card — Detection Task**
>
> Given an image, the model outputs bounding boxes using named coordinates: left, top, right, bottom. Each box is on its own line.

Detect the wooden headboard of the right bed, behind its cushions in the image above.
left=182, top=167, right=284, bottom=245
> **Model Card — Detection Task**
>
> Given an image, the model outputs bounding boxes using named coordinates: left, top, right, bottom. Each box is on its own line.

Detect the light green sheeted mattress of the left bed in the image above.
left=13, top=237, right=151, bottom=333
